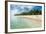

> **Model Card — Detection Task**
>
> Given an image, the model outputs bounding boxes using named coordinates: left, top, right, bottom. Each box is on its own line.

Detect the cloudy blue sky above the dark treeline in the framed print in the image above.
left=10, top=4, right=42, bottom=15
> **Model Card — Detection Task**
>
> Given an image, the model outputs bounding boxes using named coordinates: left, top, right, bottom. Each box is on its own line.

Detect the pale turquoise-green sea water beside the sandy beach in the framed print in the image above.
left=10, top=16, right=39, bottom=29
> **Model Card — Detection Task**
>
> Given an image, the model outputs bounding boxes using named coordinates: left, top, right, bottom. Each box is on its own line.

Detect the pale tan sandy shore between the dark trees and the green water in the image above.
left=15, top=15, right=42, bottom=25
